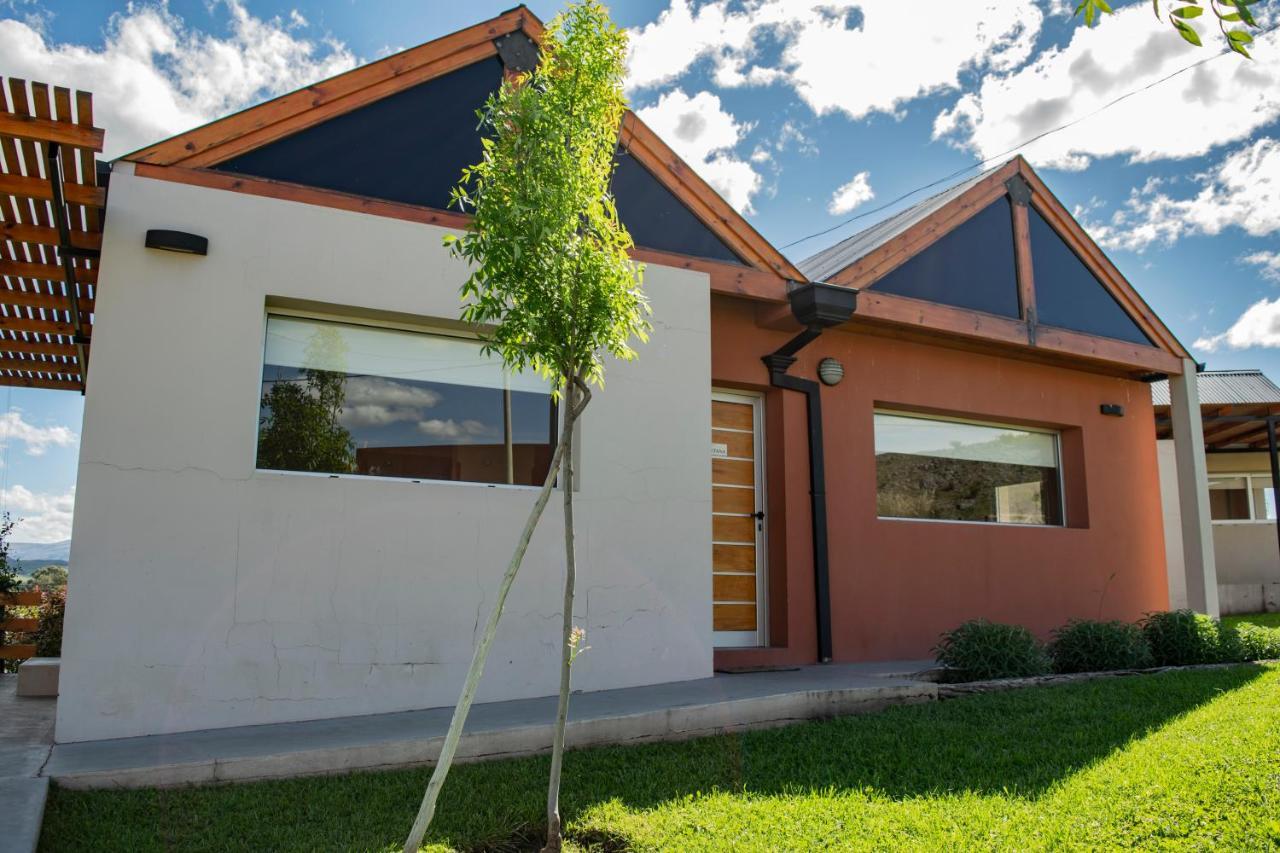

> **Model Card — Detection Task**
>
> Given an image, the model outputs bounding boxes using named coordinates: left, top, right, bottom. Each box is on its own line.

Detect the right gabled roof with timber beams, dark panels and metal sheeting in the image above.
left=799, top=156, right=1190, bottom=377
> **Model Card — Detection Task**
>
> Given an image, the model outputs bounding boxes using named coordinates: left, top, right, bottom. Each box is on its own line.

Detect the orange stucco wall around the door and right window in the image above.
left=712, top=297, right=1167, bottom=665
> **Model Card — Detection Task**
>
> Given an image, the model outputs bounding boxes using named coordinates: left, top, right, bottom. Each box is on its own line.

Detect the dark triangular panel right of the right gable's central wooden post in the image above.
left=1029, top=207, right=1155, bottom=346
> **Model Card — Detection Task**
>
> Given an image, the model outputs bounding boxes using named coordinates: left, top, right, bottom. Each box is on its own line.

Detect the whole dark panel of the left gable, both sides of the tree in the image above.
left=215, top=58, right=742, bottom=264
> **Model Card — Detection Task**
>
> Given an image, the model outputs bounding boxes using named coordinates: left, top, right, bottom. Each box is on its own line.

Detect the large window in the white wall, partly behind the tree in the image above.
left=257, top=315, right=556, bottom=485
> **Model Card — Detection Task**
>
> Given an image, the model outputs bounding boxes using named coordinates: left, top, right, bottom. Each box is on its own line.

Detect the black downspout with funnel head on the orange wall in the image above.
left=763, top=283, right=858, bottom=663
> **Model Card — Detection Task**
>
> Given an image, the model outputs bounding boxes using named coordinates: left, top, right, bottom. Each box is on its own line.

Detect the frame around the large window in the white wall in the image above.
left=253, top=308, right=560, bottom=492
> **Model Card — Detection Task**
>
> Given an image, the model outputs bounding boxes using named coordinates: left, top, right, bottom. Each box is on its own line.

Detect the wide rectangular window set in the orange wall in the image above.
left=876, top=411, right=1062, bottom=525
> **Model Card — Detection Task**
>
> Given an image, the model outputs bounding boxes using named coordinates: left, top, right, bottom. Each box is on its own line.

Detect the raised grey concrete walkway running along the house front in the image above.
left=44, top=661, right=937, bottom=788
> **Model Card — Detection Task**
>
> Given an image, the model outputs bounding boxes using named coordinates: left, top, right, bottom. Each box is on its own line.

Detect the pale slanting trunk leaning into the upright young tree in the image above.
left=404, top=427, right=572, bottom=853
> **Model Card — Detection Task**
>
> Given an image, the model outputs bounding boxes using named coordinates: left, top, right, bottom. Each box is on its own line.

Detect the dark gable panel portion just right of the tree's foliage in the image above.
left=613, top=151, right=742, bottom=264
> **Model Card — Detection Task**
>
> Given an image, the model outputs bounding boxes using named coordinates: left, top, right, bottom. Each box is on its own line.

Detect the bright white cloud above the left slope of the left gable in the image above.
left=0, top=0, right=356, bottom=156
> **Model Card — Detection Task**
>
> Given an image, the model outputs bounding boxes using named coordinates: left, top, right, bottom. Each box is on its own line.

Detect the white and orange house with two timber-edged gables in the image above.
left=0, top=8, right=1216, bottom=742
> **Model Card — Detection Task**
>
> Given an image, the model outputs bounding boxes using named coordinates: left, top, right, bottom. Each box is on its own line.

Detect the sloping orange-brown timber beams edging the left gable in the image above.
left=122, top=6, right=804, bottom=281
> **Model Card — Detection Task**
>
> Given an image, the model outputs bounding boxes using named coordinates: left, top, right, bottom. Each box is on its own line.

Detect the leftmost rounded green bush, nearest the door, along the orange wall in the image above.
left=933, top=619, right=1052, bottom=681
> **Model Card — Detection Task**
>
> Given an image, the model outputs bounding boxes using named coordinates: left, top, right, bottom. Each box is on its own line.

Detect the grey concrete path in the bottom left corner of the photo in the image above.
left=0, top=675, right=56, bottom=853
